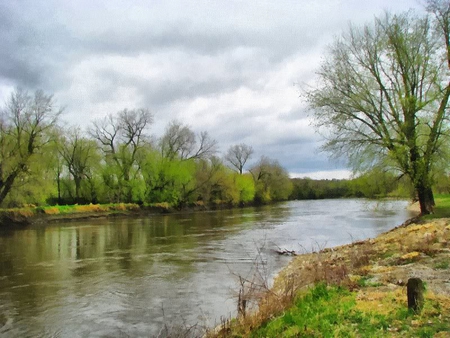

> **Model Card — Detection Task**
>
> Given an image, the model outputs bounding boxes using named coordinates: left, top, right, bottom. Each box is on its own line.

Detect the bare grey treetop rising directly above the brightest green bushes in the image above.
left=159, top=121, right=217, bottom=160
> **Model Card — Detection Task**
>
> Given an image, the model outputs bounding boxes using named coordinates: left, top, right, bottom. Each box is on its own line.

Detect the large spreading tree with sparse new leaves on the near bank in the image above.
left=307, top=1, right=450, bottom=214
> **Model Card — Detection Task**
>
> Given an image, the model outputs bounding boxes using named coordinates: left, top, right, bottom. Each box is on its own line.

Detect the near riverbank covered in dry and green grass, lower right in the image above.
left=209, top=218, right=450, bottom=337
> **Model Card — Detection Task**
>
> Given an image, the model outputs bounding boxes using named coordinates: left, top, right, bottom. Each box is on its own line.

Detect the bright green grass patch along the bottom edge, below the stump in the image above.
left=251, top=283, right=450, bottom=337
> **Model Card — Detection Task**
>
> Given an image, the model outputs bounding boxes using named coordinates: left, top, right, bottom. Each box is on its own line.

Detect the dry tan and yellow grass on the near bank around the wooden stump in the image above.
left=210, top=219, right=450, bottom=337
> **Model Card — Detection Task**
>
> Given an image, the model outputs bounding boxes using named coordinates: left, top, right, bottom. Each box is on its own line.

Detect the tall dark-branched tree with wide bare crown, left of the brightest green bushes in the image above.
left=89, top=108, right=153, bottom=202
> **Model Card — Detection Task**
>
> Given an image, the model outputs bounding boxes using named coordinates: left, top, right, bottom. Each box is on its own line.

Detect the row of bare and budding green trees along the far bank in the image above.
left=0, top=89, right=292, bottom=208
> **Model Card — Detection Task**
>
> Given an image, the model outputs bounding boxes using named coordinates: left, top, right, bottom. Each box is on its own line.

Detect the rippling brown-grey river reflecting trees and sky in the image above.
left=0, top=199, right=413, bottom=337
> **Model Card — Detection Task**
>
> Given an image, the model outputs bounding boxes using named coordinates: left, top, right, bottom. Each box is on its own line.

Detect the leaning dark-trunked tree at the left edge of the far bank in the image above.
left=0, top=89, right=62, bottom=203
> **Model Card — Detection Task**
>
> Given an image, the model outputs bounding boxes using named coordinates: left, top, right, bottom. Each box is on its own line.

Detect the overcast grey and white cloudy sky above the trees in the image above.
left=0, top=0, right=423, bottom=178
